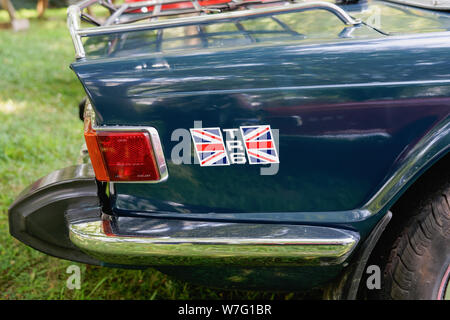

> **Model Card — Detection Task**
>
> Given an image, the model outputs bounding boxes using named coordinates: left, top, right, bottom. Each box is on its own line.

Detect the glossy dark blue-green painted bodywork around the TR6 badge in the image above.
left=72, top=2, right=450, bottom=230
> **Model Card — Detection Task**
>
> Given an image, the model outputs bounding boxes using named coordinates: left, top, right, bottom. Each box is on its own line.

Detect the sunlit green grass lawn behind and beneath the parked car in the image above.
left=0, top=9, right=306, bottom=299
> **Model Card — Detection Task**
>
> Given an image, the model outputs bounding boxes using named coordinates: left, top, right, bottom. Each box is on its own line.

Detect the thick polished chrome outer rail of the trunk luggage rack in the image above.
left=67, top=0, right=361, bottom=59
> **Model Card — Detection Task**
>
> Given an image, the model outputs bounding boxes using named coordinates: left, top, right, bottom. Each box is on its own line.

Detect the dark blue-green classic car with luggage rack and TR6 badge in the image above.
left=9, top=0, right=450, bottom=299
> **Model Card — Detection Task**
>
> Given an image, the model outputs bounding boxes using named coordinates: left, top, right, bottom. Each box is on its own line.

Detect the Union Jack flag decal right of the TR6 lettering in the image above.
left=240, top=125, right=280, bottom=164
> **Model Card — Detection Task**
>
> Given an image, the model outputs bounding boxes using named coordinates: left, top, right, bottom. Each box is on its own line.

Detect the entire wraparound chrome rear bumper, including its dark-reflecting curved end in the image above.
left=9, top=164, right=360, bottom=267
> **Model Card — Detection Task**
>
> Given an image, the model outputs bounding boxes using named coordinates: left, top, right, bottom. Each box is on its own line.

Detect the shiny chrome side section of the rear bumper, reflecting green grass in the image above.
left=69, top=218, right=359, bottom=266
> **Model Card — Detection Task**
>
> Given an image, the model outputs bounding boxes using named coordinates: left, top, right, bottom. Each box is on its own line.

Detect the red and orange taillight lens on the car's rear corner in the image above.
left=84, top=116, right=161, bottom=181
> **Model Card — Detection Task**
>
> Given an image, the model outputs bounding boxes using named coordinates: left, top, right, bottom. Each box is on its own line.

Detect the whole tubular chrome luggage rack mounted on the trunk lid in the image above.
left=67, top=0, right=361, bottom=59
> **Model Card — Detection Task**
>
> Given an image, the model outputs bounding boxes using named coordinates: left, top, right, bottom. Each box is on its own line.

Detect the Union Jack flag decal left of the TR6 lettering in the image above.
left=190, top=128, right=230, bottom=167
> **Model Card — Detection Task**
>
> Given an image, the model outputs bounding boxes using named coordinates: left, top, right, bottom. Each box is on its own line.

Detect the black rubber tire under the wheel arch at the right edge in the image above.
left=367, top=178, right=450, bottom=300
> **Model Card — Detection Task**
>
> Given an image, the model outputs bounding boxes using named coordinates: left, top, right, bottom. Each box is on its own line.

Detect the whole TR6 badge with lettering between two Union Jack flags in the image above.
left=190, top=125, right=280, bottom=167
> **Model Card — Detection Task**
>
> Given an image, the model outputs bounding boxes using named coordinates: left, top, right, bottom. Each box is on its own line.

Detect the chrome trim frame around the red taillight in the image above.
left=84, top=101, right=169, bottom=182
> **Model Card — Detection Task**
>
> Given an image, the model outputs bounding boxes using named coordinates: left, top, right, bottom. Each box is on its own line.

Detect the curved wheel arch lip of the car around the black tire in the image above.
left=324, top=127, right=450, bottom=299
